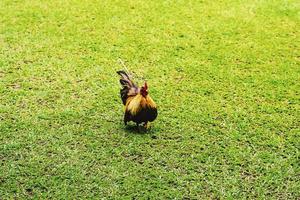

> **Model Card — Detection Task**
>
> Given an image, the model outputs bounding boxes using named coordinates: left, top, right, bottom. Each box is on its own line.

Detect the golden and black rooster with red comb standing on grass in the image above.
left=117, top=71, right=157, bottom=128
